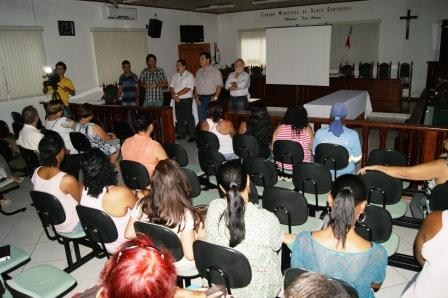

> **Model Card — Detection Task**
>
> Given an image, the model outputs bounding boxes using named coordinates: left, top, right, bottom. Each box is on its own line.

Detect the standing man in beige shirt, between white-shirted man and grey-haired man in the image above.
left=195, top=52, right=222, bottom=121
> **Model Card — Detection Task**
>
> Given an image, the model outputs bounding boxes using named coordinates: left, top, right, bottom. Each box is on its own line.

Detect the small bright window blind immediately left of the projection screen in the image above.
left=240, top=30, right=266, bottom=65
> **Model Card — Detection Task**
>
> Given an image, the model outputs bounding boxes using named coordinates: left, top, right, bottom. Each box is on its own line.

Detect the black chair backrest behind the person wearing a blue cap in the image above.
left=314, top=143, right=349, bottom=174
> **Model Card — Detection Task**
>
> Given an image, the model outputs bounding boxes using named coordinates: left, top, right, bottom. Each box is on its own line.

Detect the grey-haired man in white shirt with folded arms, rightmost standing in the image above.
left=225, top=58, right=250, bottom=111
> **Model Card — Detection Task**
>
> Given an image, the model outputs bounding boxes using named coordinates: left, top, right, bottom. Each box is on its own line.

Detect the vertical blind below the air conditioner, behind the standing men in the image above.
left=92, top=28, right=148, bottom=85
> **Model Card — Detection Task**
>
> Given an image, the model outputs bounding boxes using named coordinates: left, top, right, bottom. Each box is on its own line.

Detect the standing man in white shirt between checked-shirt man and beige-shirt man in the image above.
left=170, top=59, right=195, bottom=142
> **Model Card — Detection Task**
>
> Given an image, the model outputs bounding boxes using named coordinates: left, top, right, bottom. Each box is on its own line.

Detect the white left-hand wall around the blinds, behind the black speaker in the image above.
left=0, top=0, right=218, bottom=123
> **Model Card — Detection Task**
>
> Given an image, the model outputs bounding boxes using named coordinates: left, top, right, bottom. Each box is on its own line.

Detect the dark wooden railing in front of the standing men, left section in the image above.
left=70, top=103, right=176, bottom=143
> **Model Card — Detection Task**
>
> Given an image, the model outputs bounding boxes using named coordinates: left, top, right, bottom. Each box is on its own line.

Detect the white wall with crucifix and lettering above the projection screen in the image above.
left=218, top=0, right=448, bottom=96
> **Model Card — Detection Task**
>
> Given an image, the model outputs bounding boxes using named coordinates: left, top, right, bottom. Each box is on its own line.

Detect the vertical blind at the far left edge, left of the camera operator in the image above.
left=0, top=27, right=46, bottom=100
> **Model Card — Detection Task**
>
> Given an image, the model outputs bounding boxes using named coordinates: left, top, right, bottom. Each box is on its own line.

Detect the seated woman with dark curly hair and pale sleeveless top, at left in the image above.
left=81, top=148, right=137, bottom=253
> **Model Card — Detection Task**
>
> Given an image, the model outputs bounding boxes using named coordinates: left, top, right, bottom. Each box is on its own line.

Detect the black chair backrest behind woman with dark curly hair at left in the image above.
left=76, top=205, right=118, bottom=249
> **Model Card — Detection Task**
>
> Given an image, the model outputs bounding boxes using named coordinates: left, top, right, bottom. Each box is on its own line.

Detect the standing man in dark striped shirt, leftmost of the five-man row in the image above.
left=118, top=60, right=139, bottom=107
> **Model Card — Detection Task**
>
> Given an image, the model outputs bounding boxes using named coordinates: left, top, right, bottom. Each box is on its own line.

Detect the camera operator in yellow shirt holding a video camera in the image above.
left=43, top=61, right=76, bottom=116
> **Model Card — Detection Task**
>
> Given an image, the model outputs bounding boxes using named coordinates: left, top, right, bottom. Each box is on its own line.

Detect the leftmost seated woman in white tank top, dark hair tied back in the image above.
left=31, top=134, right=82, bottom=233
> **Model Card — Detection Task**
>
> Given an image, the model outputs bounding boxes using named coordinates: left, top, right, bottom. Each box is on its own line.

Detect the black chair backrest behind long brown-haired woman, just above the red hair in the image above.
left=134, top=221, right=184, bottom=262
